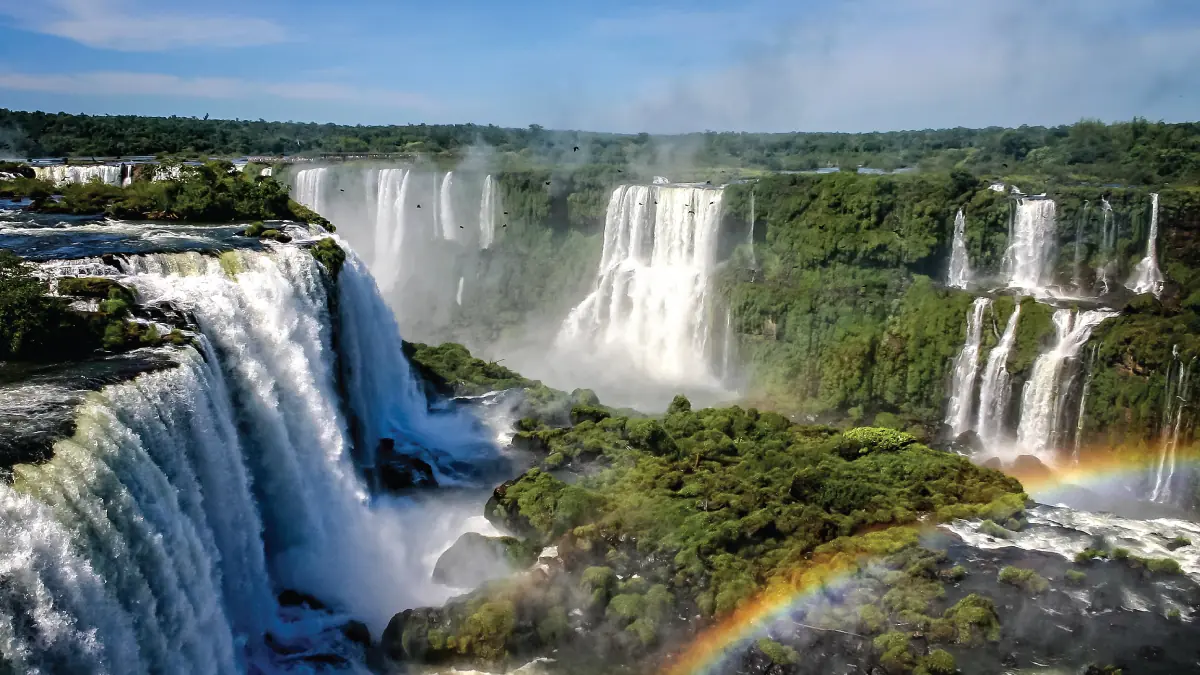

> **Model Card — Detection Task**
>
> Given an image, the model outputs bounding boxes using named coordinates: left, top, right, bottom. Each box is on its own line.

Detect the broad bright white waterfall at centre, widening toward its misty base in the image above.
left=558, top=185, right=722, bottom=382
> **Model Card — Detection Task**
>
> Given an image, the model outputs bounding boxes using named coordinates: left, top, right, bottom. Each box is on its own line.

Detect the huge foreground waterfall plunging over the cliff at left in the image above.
left=0, top=246, right=491, bottom=674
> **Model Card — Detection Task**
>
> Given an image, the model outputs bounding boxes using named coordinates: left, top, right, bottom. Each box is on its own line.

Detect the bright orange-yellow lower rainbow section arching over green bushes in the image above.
left=664, top=526, right=917, bottom=675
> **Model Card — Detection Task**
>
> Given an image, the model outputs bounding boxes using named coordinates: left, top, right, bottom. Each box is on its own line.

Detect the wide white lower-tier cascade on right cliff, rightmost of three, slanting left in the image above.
left=1016, top=310, right=1117, bottom=464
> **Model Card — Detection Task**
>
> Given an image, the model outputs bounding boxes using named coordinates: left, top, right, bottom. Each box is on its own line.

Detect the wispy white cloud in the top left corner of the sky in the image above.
left=0, top=0, right=287, bottom=52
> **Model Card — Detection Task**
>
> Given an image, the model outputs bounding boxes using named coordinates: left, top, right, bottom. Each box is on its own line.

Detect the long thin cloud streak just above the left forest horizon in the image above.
left=0, top=68, right=438, bottom=114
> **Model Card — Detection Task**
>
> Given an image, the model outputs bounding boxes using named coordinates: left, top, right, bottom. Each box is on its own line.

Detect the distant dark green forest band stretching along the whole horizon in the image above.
left=0, top=108, right=1200, bottom=185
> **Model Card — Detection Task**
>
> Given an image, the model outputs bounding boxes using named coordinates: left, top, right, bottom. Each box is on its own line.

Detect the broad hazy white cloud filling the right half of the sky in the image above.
left=571, top=0, right=1200, bottom=132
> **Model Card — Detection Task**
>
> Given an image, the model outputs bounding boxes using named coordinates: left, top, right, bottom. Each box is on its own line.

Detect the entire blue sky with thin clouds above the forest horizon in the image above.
left=0, top=0, right=1200, bottom=132
